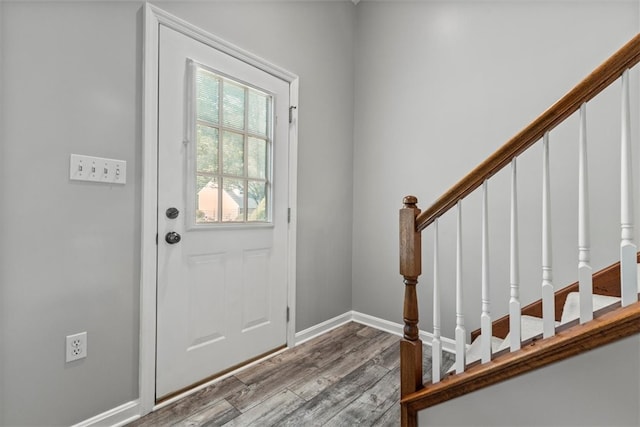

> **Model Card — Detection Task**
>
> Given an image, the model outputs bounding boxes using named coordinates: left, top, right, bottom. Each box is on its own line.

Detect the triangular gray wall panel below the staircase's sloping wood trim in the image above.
left=418, top=336, right=640, bottom=427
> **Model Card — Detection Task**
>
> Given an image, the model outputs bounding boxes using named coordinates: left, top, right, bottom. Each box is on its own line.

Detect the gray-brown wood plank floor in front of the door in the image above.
left=129, top=322, right=453, bottom=427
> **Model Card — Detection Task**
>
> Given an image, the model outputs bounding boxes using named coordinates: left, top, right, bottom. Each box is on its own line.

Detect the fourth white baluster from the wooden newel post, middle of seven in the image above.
left=509, top=157, right=522, bottom=351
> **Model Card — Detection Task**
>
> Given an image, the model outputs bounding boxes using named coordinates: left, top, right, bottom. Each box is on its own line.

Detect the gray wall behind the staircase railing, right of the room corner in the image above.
left=353, top=1, right=639, bottom=337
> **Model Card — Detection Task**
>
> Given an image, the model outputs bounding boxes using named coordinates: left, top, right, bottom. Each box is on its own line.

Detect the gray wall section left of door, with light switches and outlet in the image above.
left=0, top=2, right=142, bottom=425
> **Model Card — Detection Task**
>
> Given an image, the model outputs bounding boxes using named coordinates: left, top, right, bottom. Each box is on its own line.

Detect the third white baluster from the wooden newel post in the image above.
left=480, top=180, right=493, bottom=363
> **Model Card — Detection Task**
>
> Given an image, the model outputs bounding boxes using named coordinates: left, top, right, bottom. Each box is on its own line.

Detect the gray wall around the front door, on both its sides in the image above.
left=0, top=1, right=355, bottom=425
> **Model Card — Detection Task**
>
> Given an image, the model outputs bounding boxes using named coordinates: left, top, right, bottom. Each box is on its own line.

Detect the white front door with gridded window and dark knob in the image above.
left=156, top=25, right=289, bottom=399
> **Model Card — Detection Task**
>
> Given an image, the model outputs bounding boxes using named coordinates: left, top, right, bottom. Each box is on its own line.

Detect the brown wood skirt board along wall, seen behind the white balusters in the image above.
left=471, top=252, right=640, bottom=342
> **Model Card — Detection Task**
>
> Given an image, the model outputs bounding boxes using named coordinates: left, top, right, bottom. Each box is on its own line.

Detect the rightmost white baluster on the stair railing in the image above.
left=620, top=70, right=638, bottom=307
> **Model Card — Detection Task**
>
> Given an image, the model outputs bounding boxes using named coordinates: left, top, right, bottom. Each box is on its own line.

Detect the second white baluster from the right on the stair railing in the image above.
left=578, top=103, right=593, bottom=323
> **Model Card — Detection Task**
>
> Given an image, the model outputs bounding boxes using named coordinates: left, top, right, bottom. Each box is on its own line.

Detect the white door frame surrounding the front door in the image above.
left=138, top=3, right=299, bottom=415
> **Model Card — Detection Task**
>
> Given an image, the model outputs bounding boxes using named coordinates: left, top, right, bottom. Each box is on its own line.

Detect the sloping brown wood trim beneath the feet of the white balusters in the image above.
left=400, top=302, right=640, bottom=413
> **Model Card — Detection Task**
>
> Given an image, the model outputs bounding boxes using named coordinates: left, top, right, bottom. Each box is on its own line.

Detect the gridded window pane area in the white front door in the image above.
left=188, top=63, right=273, bottom=225
